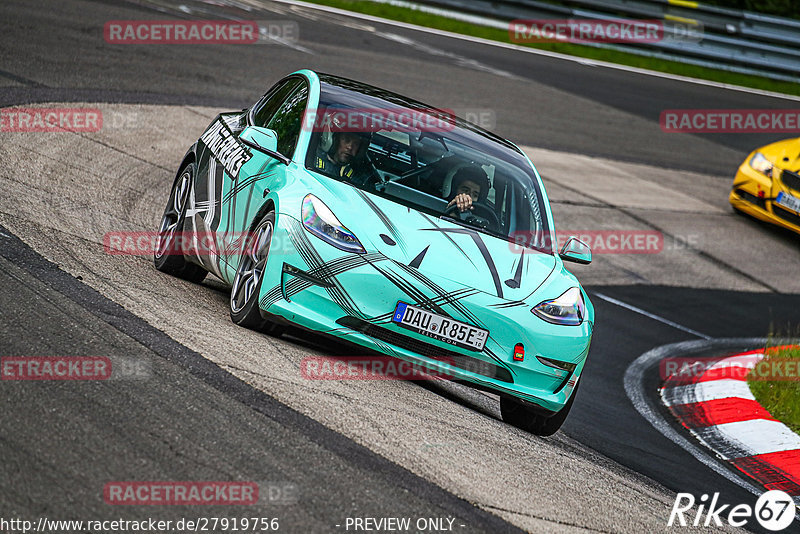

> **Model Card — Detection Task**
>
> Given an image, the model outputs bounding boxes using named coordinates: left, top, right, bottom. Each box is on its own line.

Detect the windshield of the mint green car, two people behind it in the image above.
left=306, top=75, right=552, bottom=254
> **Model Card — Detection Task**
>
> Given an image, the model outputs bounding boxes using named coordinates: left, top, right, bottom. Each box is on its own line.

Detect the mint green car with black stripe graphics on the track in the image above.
left=155, top=70, right=594, bottom=435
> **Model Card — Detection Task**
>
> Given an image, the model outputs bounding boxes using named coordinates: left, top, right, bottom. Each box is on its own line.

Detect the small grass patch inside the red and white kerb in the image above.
left=747, top=346, right=800, bottom=433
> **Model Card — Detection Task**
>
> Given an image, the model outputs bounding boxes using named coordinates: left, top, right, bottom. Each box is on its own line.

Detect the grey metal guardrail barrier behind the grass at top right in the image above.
left=378, top=0, right=800, bottom=82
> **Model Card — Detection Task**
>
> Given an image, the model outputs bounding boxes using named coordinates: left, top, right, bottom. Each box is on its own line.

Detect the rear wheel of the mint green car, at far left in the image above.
left=153, top=163, right=208, bottom=283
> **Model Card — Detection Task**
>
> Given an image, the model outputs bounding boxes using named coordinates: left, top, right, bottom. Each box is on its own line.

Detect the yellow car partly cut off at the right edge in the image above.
left=729, top=138, right=800, bottom=234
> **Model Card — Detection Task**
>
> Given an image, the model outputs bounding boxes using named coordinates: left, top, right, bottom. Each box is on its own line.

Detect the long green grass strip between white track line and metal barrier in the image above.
left=307, top=0, right=800, bottom=95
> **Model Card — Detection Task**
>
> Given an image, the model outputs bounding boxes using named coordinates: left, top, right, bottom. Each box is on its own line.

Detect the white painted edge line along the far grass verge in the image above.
left=269, top=0, right=800, bottom=102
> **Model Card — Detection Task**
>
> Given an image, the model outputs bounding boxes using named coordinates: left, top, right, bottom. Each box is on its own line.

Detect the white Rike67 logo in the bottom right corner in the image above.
left=667, top=490, right=797, bottom=532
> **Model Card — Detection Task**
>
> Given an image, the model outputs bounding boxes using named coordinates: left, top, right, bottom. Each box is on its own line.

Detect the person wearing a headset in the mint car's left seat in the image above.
left=314, top=113, right=373, bottom=186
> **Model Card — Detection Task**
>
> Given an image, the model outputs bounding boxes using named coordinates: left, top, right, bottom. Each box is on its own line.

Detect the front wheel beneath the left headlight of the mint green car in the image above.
left=229, top=210, right=283, bottom=336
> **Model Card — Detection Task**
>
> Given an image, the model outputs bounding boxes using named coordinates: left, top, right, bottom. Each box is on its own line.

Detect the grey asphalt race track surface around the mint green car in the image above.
left=0, top=1, right=800, bottom=532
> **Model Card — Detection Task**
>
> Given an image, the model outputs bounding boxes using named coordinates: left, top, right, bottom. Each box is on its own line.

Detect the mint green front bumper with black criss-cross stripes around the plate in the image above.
left=260, top=213, right=593, bottom=412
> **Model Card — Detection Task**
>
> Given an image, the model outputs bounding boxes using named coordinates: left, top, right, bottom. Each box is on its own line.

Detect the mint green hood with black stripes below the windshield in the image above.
left=316, top=184, right=556, bottom=300
